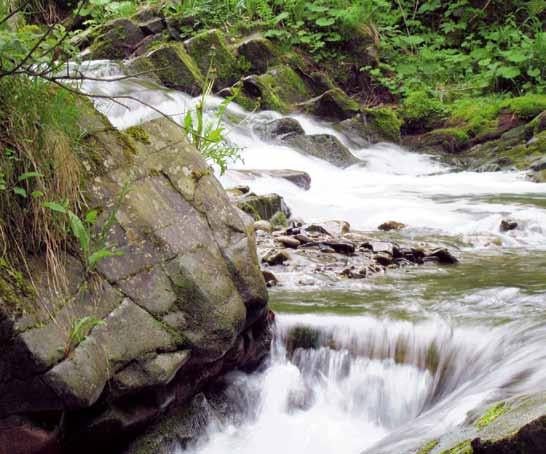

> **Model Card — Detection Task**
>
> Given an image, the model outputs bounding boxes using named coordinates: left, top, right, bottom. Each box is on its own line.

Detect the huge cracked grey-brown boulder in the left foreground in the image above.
left=0, top=109, right=268, bottom=454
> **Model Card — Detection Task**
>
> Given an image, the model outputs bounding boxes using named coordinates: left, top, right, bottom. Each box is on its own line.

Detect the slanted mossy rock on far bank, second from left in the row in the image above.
left=140, top=43, right=204, bottom=95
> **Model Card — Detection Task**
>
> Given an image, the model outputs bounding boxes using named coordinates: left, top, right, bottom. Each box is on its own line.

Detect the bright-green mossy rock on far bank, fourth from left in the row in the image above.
left=241, top=65, right=313, bottom=113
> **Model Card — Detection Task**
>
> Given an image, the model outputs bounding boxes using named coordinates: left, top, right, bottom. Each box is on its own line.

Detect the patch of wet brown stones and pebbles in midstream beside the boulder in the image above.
left=256, top=221, right=458, bottom=287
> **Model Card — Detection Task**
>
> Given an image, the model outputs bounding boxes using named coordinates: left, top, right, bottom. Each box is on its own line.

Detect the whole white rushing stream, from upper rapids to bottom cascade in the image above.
left=77, top=62, right=546, bottom=454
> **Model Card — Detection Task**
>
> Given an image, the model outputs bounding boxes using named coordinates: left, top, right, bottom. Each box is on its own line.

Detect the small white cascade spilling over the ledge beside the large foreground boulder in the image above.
left=182, top=315, right=546, bottom=454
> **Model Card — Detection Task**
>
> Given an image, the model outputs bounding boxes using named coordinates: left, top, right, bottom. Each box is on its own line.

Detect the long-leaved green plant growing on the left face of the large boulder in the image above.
left=44, top=185, right=129, bottom=272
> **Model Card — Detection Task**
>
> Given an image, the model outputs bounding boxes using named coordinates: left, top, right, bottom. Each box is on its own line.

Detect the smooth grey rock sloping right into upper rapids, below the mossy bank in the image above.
left=283, top=134, right=362, bottom=168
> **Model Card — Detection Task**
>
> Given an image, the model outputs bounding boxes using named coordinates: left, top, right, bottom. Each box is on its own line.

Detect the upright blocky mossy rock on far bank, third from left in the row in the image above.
left=184, top=30, right=244, bottom=90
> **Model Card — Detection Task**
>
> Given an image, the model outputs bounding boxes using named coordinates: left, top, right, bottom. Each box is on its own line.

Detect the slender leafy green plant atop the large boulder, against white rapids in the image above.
left=183, top=71, right=241, bottom=174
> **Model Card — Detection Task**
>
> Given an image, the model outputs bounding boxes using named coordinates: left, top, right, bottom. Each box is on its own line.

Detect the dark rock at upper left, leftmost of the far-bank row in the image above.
left=90, top=19, right=144, bottom=60
